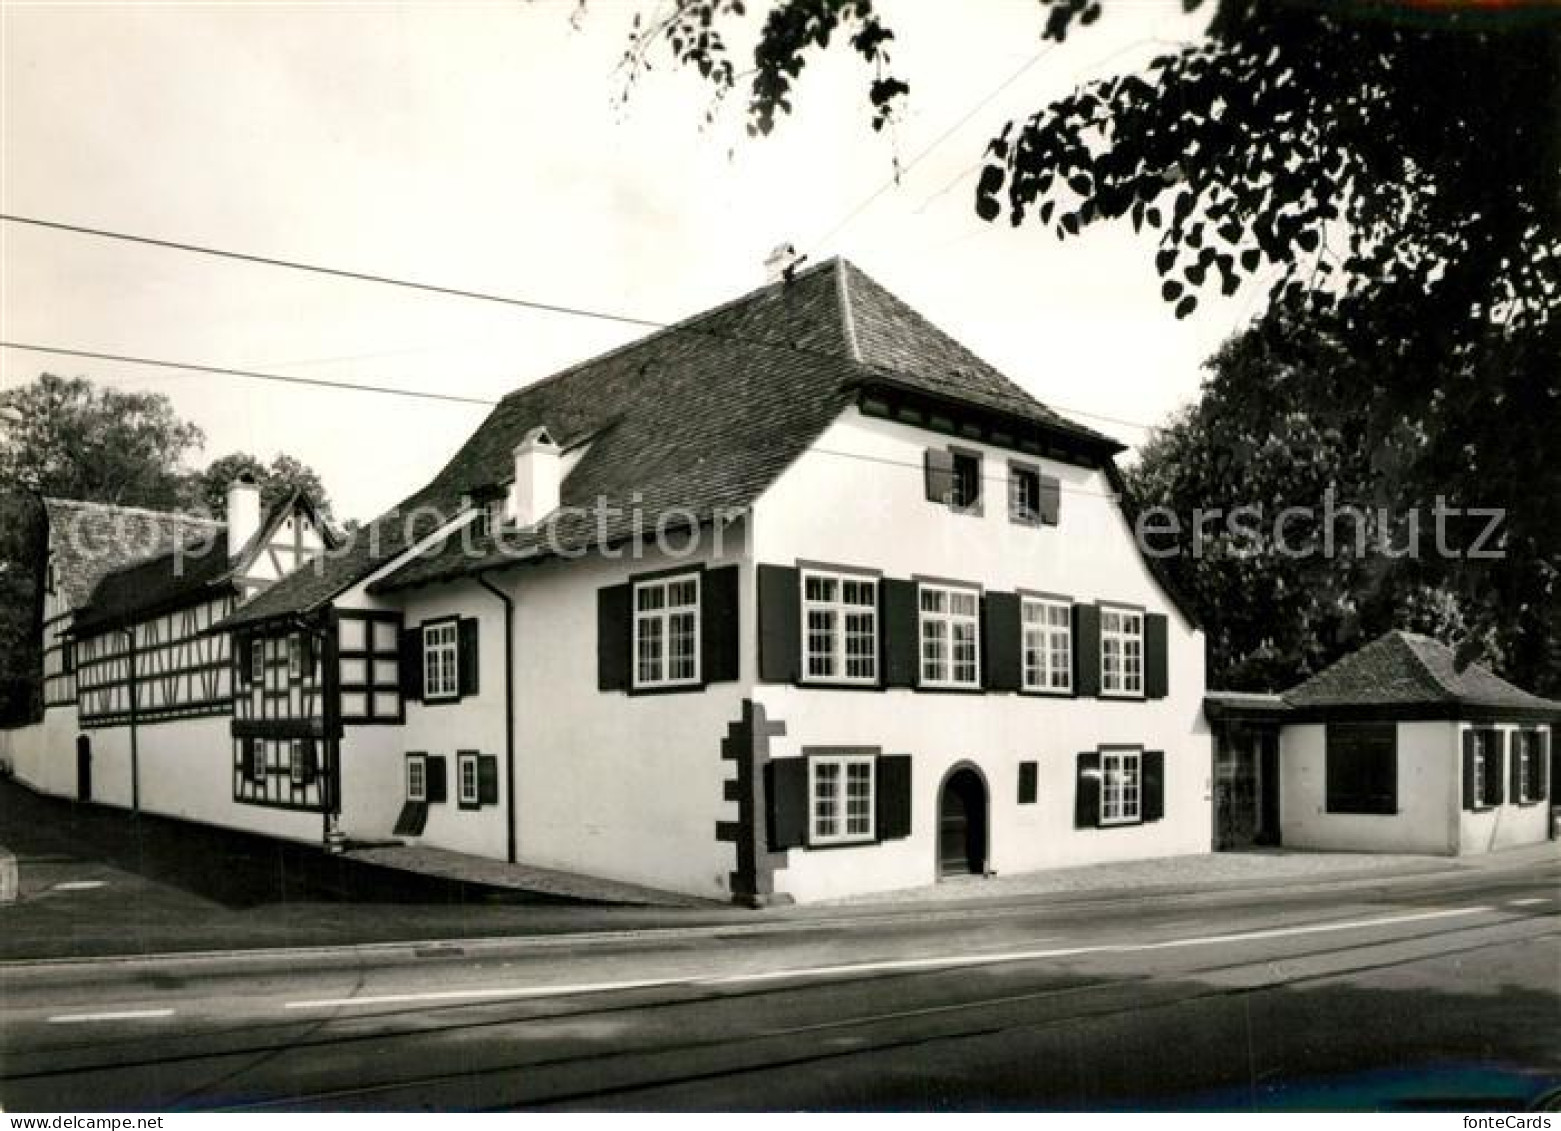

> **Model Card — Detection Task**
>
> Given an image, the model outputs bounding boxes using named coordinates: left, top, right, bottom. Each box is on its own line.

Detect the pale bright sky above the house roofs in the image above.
left=0, top=0, right=1261, bottom=518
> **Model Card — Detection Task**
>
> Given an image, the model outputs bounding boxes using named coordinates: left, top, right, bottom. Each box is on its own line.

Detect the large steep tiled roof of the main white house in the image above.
left=228, top=261, right=1121, bottom=624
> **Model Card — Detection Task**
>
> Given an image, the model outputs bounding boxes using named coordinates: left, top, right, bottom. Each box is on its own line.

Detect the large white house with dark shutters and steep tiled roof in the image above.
left=6, top=261, right=1213, bottom=903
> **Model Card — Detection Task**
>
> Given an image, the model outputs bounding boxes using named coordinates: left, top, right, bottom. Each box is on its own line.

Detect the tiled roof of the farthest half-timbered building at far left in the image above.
left=44, top=499, right=223, bottom=610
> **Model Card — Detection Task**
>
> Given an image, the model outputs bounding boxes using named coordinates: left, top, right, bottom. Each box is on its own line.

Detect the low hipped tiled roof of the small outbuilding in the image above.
left=1283, top=630, right=1561, bottom=710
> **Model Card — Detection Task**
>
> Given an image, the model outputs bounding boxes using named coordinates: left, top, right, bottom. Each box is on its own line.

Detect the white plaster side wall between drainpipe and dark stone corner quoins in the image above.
left=502, top=524, right=756, bottom=899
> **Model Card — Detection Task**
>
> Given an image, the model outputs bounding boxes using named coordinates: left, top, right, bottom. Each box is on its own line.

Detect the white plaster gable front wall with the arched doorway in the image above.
left=754, top=409, right=1213, bottom=900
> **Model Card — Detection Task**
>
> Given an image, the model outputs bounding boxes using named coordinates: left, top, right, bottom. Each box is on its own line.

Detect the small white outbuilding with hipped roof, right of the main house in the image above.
left=1205, top=630, right=1561, bottom=855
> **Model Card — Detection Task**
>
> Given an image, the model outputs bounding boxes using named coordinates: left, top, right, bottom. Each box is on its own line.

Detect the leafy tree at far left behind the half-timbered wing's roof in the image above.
left=0, top=373, right=204, bottom=507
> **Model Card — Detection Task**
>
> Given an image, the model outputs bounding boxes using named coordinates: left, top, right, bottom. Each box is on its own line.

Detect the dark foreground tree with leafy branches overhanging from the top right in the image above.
left=626, top=0, right=1561, bottom=675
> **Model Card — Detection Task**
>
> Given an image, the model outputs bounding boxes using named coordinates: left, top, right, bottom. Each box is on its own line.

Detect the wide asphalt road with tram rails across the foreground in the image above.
left=0, top=861, right=1561, bottom=1111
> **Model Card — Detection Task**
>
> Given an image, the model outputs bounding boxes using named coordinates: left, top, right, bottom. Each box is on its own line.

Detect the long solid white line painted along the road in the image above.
left=283, top=905, right=1495, bottom=1009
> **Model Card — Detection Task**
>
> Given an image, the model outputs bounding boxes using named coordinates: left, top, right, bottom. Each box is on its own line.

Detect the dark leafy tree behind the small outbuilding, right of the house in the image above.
left=1127, top=308, right=1517, bottom=691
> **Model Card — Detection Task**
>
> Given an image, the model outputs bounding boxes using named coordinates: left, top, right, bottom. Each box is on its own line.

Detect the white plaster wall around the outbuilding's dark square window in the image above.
left=1278, top=722, right=1461, bottom=855
